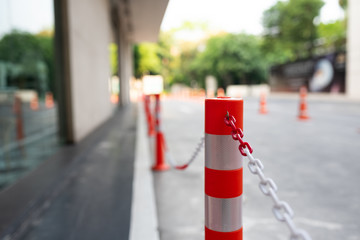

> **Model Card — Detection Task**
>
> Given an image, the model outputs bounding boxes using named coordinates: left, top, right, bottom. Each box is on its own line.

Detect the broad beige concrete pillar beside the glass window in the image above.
left=67, top=0, right=114, bottom=142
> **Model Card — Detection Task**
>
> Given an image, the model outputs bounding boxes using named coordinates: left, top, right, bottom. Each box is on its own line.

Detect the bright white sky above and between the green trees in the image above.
left=161, top=0, right=344, bottom=34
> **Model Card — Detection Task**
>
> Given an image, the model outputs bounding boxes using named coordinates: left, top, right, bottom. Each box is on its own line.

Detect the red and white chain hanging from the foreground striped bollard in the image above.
left=224, top=113, right=311, bottom=240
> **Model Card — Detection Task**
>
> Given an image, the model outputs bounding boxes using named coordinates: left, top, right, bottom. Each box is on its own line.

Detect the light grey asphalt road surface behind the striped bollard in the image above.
left=154, top=96, right=360, bottom=240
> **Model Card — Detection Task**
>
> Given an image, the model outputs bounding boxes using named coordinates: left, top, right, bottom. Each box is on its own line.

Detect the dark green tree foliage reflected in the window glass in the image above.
left=0, top=31, right=55, bottom=94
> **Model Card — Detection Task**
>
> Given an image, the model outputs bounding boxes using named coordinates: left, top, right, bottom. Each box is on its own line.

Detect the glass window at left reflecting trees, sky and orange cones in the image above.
left=0, top=0, right=59, bottom=191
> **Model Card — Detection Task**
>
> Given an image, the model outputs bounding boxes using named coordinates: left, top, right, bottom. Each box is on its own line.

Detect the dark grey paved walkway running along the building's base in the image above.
left=0, top=106, right=137, bottom=240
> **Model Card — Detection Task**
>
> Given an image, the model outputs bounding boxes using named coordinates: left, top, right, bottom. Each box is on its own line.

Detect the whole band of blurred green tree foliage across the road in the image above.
left=134, top=0, right=347, bottom=88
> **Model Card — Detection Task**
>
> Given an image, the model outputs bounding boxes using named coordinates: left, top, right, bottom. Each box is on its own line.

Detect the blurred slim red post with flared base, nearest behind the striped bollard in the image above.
left=152, top=94, right=170, bottom=171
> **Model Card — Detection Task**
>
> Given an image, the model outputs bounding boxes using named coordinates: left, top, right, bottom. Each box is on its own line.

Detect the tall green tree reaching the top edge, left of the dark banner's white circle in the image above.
left=263, top=0, right=324, bottom=60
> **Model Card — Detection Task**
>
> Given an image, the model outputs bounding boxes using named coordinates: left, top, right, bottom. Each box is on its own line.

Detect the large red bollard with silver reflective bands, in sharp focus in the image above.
left=205, top=97, right=243, bottom=240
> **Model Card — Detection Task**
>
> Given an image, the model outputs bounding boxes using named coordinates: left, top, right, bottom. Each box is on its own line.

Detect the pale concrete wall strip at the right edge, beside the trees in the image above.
left=346, top=0, right=360, bottom=99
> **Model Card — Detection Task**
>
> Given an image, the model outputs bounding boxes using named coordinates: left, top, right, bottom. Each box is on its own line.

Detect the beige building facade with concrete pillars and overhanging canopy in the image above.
left=55, top=0, right=168, bottom=142
